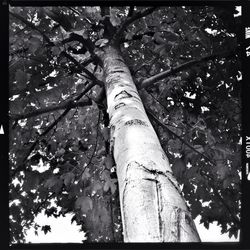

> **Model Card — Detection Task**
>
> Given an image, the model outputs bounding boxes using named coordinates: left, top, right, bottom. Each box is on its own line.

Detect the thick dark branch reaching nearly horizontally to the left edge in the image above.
left=10, top=99, right=92, bottom=120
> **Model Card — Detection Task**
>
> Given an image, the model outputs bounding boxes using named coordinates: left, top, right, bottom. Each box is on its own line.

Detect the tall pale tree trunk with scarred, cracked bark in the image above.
left=102, top=45, right=200, bottom=242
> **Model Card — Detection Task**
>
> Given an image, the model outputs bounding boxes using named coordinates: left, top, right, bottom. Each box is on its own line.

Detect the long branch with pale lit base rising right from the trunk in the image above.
left=139, top=51, right=235, bottom=89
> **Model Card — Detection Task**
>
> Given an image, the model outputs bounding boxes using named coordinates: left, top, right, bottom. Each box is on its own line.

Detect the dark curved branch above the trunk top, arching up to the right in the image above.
left=114, top=7, right=157, bottom=40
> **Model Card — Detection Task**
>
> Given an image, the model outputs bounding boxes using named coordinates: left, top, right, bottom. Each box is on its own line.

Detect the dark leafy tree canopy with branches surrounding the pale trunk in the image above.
left=9, top=6, right=241, bottom=243
